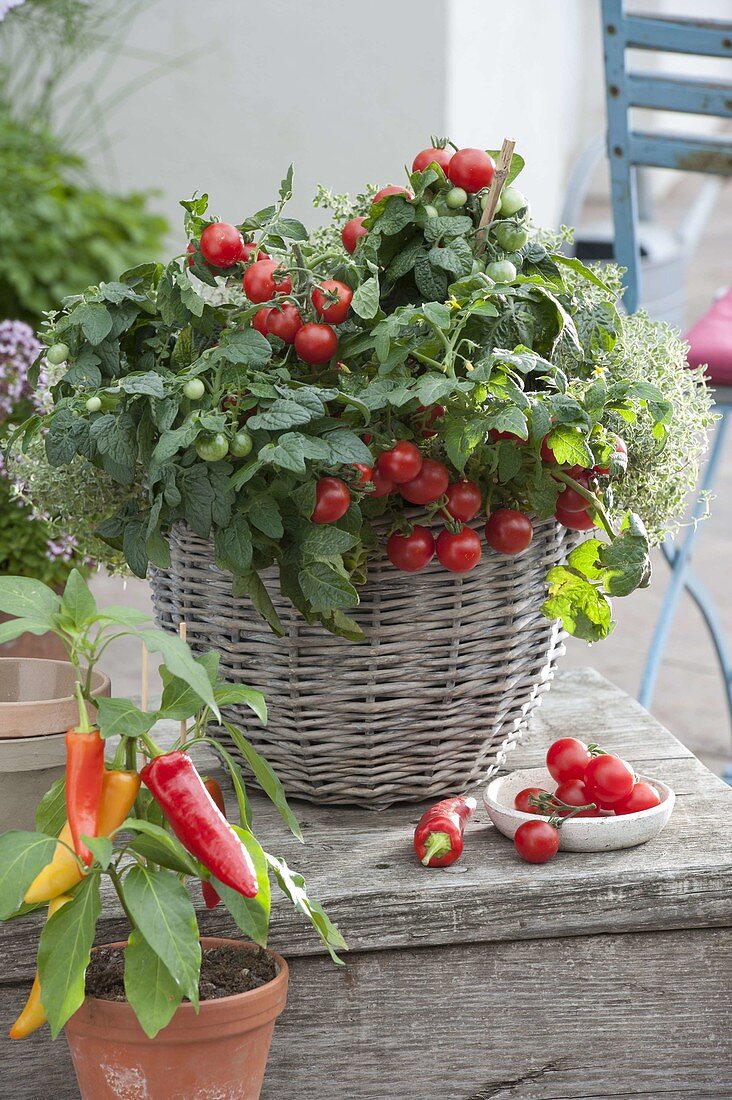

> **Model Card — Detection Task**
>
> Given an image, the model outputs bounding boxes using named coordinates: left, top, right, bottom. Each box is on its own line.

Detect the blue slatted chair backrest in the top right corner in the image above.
left=601, top=0, right=732, bottom=312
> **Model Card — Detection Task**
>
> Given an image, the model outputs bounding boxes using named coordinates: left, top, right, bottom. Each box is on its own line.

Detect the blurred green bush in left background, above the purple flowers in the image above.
left=0, top=111, right=166, bottom=326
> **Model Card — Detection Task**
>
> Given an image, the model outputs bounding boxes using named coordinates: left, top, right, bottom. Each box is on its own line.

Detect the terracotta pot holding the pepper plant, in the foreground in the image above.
left=66, top=936, right=287, bottom=1100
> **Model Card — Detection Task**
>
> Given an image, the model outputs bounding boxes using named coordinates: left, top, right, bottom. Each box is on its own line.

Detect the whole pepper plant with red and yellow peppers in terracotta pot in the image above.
left=0, top=571, right=346, bottom=1038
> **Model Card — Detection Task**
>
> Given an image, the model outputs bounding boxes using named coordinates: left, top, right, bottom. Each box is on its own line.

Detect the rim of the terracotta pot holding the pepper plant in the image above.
left=66, top=936, right=289, bottom=1043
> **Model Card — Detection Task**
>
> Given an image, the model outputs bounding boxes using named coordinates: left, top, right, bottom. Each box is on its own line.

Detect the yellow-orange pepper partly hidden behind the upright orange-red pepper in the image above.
left=23, top=771, right=140, bottom=905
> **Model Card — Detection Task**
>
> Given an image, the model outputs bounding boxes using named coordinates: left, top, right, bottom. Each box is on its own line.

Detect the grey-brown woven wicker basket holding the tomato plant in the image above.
left=151, top=520, right=575, bottom=809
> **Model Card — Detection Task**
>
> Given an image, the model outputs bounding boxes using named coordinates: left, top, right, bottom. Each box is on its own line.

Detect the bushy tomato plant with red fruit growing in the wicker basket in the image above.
left=17, top=146, right=709, bottom=641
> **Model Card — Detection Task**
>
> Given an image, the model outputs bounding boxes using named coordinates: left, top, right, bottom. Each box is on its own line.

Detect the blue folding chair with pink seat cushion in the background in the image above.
left=601, top=0, right=732, bottom=765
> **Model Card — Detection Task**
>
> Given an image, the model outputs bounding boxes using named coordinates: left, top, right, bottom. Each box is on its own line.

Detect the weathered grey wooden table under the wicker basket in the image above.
left=0, top=670, right=732, bottom=1100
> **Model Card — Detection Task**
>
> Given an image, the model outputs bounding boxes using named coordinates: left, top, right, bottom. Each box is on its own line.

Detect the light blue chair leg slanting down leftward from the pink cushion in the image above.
left=638, top=406, right=732, bottom=708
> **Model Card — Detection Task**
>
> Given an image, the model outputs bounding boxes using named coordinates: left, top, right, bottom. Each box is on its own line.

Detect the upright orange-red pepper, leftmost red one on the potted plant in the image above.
left=65, top=683, right=105, bottom=867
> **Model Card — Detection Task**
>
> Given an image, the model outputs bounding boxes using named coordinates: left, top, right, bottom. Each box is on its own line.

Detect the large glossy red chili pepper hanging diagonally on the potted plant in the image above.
left=140, top=750, right=259, bottom=898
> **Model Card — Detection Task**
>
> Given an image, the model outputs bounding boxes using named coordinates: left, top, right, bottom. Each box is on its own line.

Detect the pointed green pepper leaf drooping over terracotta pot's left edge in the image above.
left=39, top=875, right=101, bottom=1038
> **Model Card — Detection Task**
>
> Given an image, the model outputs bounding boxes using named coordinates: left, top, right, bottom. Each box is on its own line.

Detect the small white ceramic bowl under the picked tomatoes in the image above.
left=483, top=768, right=676, bottom=851
